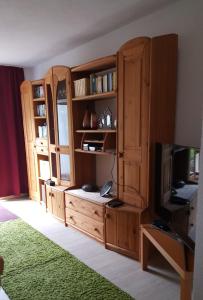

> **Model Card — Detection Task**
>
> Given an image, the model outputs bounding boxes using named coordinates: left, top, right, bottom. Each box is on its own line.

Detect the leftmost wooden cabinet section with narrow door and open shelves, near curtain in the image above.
left=21, top=80, right=49, bottom=201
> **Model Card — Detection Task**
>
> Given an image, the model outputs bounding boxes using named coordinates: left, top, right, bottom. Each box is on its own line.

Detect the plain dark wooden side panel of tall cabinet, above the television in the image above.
left=150, top=34, right=178, bottom=144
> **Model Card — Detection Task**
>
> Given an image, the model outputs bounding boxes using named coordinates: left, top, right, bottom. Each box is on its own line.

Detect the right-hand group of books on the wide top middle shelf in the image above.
left=90, top=71, right=117, bottom=95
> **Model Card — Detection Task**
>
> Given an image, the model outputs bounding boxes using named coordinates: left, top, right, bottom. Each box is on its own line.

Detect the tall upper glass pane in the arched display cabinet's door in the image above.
left=56, top=79, right=69, bottom=146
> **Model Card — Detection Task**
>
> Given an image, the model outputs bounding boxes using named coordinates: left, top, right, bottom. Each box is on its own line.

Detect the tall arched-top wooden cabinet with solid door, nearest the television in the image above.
left=118, top=34, right=177, bottom=208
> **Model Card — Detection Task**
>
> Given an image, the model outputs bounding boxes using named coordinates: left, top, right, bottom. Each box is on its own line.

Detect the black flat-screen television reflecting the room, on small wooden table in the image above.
left=154, top=143, right=200, bottom=248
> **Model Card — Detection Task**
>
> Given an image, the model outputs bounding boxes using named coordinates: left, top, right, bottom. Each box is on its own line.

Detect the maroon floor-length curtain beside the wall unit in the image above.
left=0, top=66, right=28, bottom=197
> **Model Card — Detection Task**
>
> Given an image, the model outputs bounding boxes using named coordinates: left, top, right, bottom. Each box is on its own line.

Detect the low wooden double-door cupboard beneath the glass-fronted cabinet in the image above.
left=46, top=185, right=66, bottom=221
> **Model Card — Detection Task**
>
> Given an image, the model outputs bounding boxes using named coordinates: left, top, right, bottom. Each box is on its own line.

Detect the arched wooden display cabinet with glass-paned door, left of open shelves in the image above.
left=45, top=66, right=74, bottom=186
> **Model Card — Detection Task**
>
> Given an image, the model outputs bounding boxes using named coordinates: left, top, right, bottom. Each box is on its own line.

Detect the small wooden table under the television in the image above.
left=141, top=224, right=194, bottom=300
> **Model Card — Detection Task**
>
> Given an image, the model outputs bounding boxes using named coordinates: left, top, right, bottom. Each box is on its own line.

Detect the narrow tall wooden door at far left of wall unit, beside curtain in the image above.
left=21, top=81, right=39, bottom=200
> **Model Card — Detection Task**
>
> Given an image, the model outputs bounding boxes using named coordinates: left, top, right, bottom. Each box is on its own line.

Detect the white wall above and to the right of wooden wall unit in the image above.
left=26, top=0, right=203, bottom=146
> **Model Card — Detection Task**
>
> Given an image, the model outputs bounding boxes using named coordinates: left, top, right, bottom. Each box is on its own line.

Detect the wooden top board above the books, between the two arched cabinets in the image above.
left=71, top=55, right=116, bottom=72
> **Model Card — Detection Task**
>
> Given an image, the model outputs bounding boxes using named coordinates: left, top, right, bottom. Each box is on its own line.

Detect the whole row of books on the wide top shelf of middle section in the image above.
left=74, top=70, right=117, bottom=97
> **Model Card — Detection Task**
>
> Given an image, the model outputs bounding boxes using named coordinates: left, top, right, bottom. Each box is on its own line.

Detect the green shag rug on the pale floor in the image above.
left=0, top=219, right=132, bottom=300
